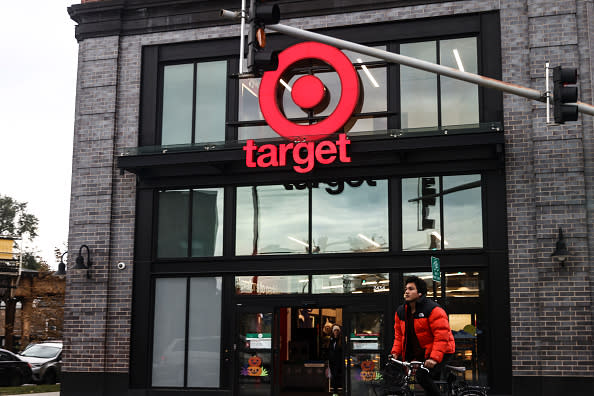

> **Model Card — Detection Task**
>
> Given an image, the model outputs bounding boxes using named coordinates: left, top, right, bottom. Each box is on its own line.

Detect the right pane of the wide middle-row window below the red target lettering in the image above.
left=312, top=180, right=389, bottom=253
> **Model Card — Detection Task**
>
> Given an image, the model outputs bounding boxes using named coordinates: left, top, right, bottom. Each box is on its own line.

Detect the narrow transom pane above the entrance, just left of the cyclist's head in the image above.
left=312, top=273, right=390, bottom=294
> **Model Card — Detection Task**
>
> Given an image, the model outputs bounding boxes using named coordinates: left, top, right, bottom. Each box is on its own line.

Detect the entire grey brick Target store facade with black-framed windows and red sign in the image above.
left=61, top=0, right=594, bottom=396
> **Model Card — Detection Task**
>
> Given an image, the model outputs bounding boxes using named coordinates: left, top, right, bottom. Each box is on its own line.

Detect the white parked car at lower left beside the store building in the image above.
left=19, top=341, right=62, bottom=384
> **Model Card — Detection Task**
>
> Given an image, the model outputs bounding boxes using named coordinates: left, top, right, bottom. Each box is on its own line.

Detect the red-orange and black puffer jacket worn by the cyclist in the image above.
left=392, top=296, right=456, bottom=363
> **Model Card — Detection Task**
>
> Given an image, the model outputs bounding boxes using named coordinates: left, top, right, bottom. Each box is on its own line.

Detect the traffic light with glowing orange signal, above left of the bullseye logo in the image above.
left=247, top=0, right=280, bottom=76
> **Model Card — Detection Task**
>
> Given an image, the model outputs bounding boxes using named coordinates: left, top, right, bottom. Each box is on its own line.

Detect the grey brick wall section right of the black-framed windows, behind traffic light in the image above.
left=501, top=0, right=594, bottom=376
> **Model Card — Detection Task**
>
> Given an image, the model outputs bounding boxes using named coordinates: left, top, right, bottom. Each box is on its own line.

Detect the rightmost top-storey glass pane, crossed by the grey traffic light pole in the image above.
left=439, top=37, right=479, bottom=125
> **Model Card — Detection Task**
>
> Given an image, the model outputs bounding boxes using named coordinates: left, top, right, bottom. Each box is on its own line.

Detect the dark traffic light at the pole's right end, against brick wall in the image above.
left=553, top=66, right=578, bottom=124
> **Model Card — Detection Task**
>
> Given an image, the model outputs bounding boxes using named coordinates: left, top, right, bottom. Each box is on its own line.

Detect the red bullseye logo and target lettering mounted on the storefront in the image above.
left=243, top=42, right=359, bottom=173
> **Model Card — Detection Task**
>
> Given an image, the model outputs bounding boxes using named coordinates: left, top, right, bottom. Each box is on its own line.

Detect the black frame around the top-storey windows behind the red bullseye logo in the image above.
left=138, top=13, right=503, bottom=146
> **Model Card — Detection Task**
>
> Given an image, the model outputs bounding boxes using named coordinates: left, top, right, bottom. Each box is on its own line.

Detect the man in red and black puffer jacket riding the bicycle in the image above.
left=391, top=276, right=456, bottom=396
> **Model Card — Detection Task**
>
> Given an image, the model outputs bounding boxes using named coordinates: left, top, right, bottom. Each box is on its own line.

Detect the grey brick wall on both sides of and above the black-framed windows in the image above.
left=64, top=0, right=594, bottom=386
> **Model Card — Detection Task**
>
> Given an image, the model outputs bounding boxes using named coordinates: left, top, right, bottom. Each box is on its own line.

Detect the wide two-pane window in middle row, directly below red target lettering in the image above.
left=236, top=180, right=389, bottom=255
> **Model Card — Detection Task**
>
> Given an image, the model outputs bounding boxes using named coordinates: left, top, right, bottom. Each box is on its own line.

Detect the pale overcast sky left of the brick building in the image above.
left=0, top=0, right=78, bottom=268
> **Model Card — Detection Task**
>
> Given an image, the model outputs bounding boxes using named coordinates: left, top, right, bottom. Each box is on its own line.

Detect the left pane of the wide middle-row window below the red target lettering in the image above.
left=235, top=185, right=309, bottom=255
